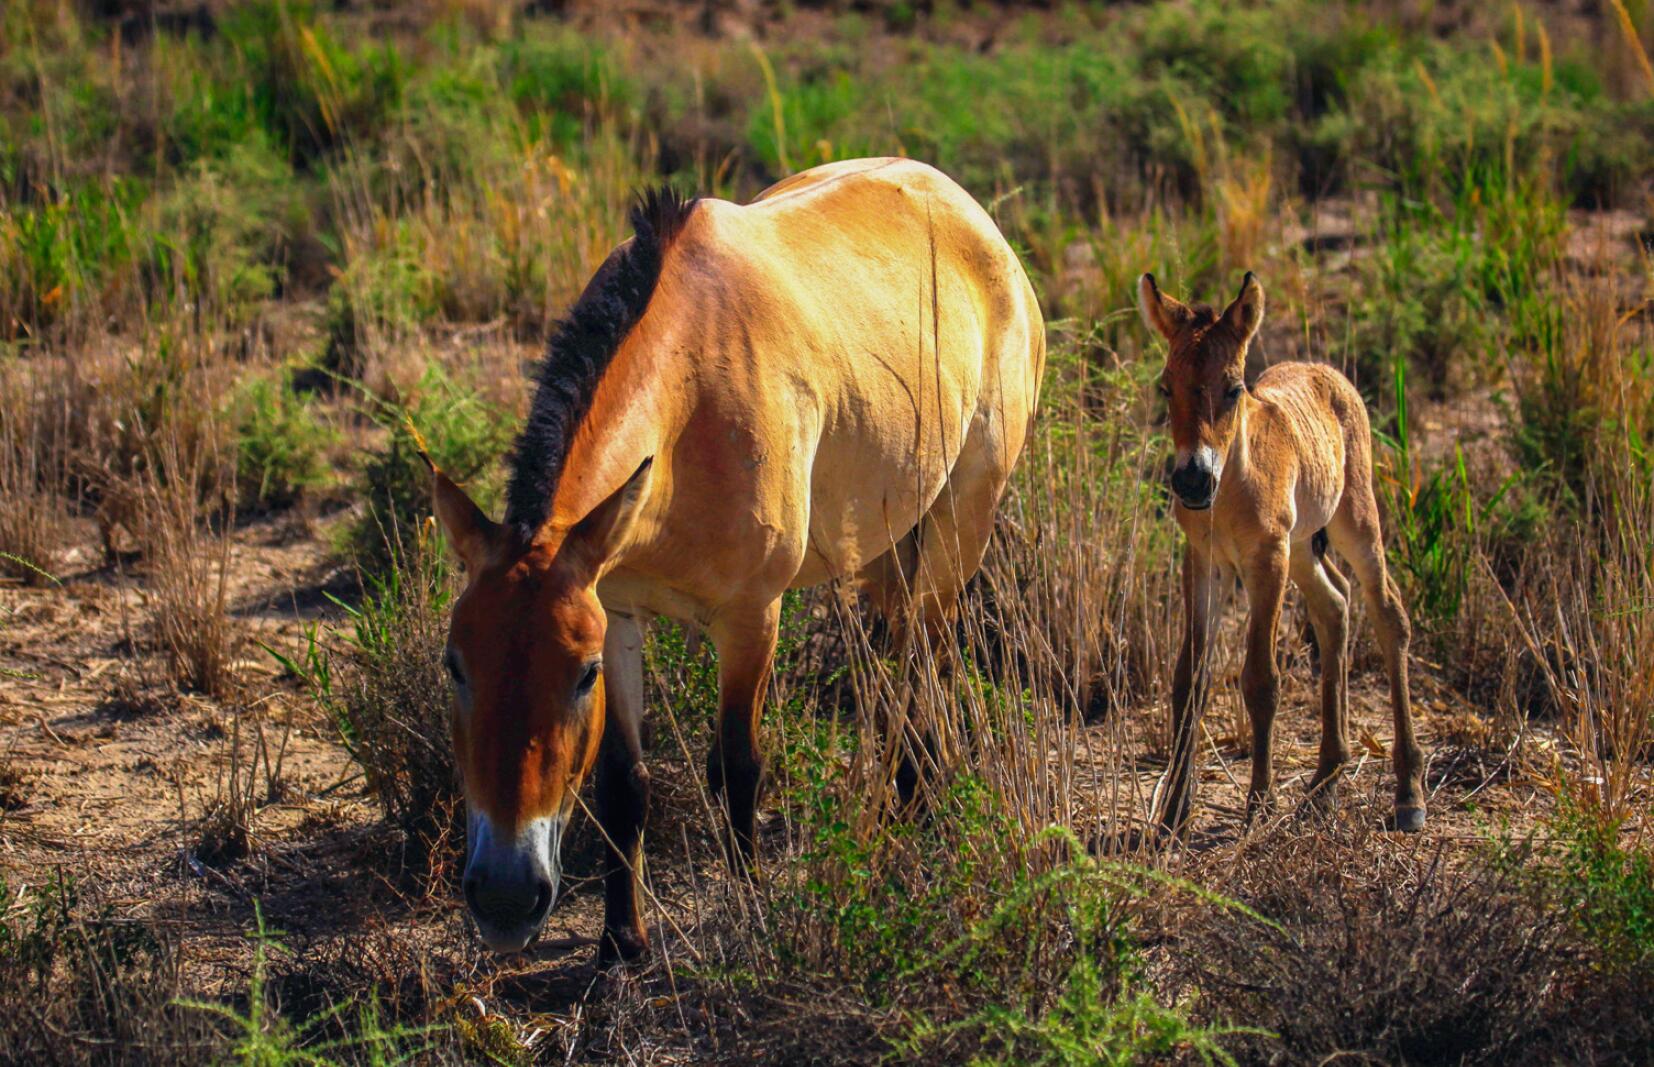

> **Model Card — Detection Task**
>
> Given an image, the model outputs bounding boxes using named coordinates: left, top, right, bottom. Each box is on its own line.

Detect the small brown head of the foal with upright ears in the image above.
left=1138, top=271, right=1264, bottom=511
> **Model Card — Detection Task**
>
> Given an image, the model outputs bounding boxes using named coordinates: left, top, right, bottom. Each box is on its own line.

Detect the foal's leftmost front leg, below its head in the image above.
left=1154, top=544, right=1231, bottom=834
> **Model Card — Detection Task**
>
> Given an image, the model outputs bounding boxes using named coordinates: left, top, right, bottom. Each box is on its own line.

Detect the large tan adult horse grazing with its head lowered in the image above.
left=435, top=159, right=1045, bottom=963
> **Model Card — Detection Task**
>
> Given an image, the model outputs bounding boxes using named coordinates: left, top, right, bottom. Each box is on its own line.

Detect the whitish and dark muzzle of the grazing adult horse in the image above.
left=463, top=814, right=562, bottom=953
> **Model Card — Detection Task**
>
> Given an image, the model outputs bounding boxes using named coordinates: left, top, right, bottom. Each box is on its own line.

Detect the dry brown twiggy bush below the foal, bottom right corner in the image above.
left=1174, top=811, right=1649, bottom=1065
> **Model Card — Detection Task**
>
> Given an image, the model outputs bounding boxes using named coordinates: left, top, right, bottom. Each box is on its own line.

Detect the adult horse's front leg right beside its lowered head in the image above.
left=597, top=614, right=648, bottom=964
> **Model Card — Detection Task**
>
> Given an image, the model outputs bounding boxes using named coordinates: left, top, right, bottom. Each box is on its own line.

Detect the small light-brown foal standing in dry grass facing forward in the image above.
left=1138, top=271, right=1424, bottom=834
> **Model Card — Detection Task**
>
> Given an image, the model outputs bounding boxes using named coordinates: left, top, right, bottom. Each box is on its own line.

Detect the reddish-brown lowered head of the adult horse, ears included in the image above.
left=435, top=462, right=650, bottom=951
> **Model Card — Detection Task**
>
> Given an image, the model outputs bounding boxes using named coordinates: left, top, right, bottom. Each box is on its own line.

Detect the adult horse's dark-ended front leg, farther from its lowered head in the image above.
left=706, top=599, right=781, bottom=870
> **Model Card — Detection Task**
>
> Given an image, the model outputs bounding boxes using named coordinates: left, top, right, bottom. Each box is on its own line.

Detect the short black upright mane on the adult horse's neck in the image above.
left=506, top=187, right=696, bottom=536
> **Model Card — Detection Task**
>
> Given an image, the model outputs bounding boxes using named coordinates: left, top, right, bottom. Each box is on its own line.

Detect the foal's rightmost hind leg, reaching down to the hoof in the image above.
left=1327, top=483, right=1424, bottom=832
